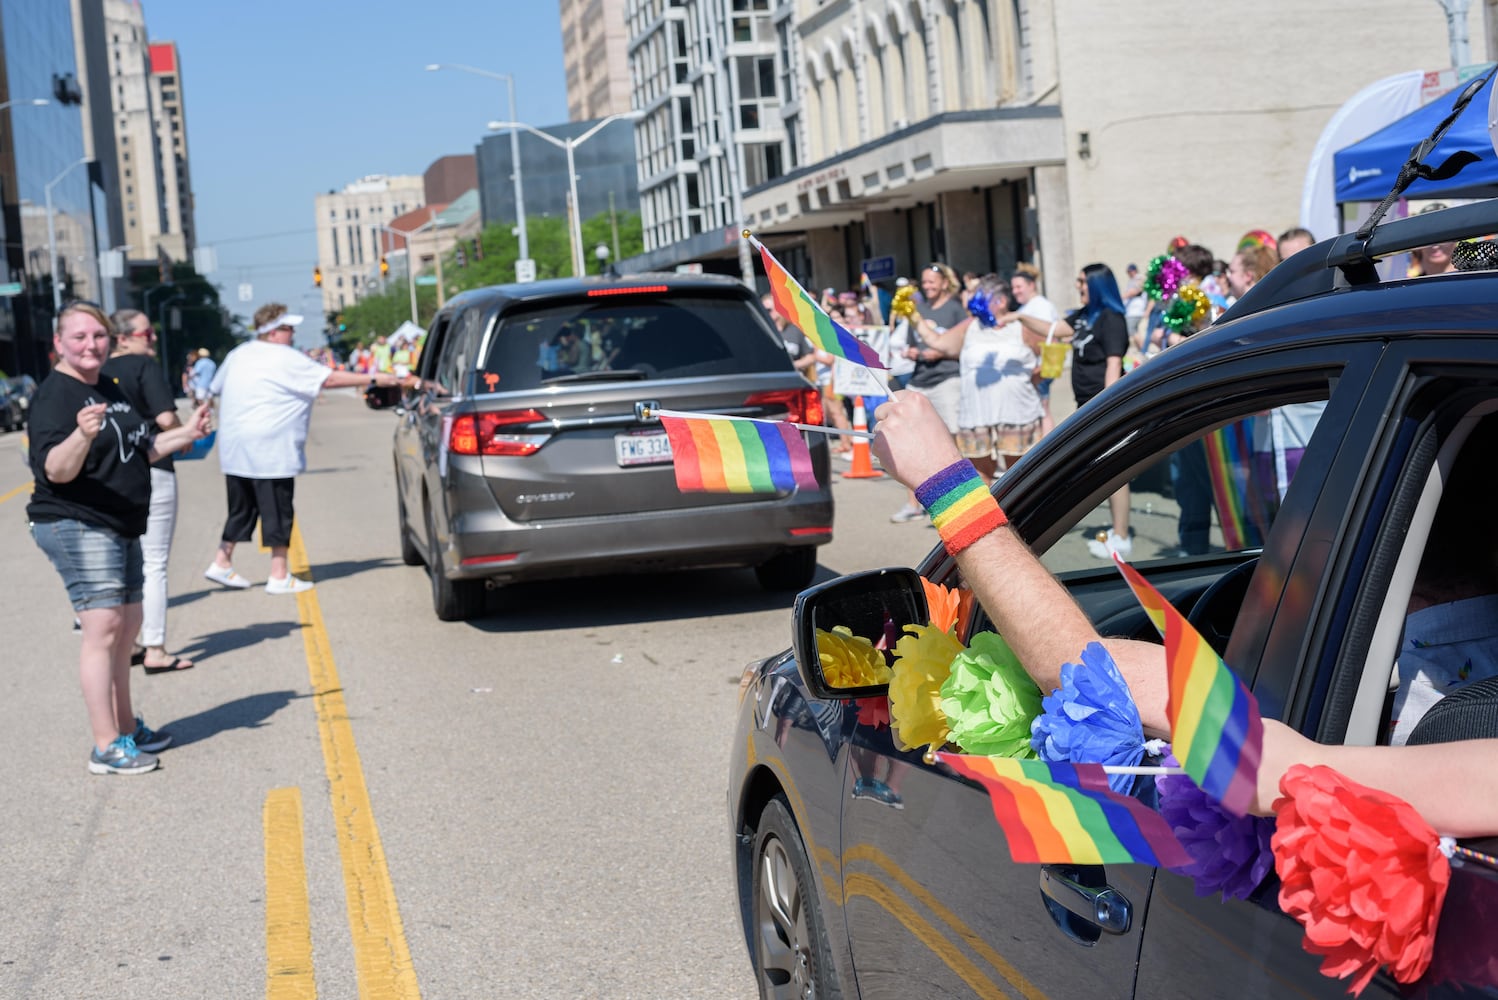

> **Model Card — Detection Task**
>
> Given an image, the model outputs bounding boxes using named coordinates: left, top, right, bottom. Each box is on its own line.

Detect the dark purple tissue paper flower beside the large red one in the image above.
left=1155, top=756, right=1275, bottom=900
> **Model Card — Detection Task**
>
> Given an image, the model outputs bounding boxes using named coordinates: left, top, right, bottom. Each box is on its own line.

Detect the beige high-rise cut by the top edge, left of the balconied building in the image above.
left=562, top=0, right=629, bottom=121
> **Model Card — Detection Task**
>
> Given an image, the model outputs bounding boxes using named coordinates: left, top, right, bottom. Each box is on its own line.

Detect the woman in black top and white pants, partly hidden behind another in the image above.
left=102, top=308, right=193, bottom=674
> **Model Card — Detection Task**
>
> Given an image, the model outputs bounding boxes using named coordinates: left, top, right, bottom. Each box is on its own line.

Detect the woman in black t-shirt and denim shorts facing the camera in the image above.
left=25, top=302, right=208, bottom=774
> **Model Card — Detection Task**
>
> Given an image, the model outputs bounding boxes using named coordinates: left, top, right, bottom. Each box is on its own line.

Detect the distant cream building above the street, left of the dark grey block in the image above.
left=315, top=174, right=425, bottom=313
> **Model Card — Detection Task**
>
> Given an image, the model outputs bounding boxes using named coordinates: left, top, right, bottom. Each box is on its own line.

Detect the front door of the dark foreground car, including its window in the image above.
left=842, top=345, right=1356, bottom=1000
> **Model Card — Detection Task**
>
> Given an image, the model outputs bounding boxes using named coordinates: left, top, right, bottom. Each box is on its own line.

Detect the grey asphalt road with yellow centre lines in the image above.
left=0, top=392, right=936, bottom=1000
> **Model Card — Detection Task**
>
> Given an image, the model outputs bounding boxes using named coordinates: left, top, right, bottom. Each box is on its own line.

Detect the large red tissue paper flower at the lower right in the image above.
left=1272, top=763, right=1452, bottom=996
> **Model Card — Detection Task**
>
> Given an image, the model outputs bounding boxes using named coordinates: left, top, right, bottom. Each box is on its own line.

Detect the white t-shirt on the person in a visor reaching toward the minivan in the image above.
left=211, top=340, right=333, bottom=479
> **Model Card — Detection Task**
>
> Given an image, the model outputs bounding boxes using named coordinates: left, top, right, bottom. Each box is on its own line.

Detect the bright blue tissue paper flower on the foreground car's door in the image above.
left=1031, top=642, right=1144, bottom=793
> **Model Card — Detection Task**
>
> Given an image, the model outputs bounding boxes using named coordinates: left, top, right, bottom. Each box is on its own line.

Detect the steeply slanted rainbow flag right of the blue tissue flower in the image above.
left=1115, top=557, right=1264, bottom=816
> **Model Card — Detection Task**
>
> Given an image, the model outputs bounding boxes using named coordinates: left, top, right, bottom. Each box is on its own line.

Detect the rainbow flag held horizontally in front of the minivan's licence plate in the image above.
left=661, top=415, right=816, bottom=493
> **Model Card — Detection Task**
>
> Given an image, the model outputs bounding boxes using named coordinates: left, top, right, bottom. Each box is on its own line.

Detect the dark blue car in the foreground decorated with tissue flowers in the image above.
left=728, top=202, right=1498, bottom=1000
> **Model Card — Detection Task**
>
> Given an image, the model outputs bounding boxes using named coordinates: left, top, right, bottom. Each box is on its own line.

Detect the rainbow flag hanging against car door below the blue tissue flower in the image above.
left=935, top=753, right=1191, bottom=868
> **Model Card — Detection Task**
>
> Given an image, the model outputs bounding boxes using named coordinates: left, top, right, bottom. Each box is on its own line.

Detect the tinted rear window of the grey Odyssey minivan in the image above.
left=479, top=293, right=791, bottom=392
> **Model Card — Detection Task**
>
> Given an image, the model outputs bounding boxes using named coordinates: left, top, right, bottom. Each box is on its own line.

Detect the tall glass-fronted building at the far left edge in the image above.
left=0, top=0, right=94, bottom=376
